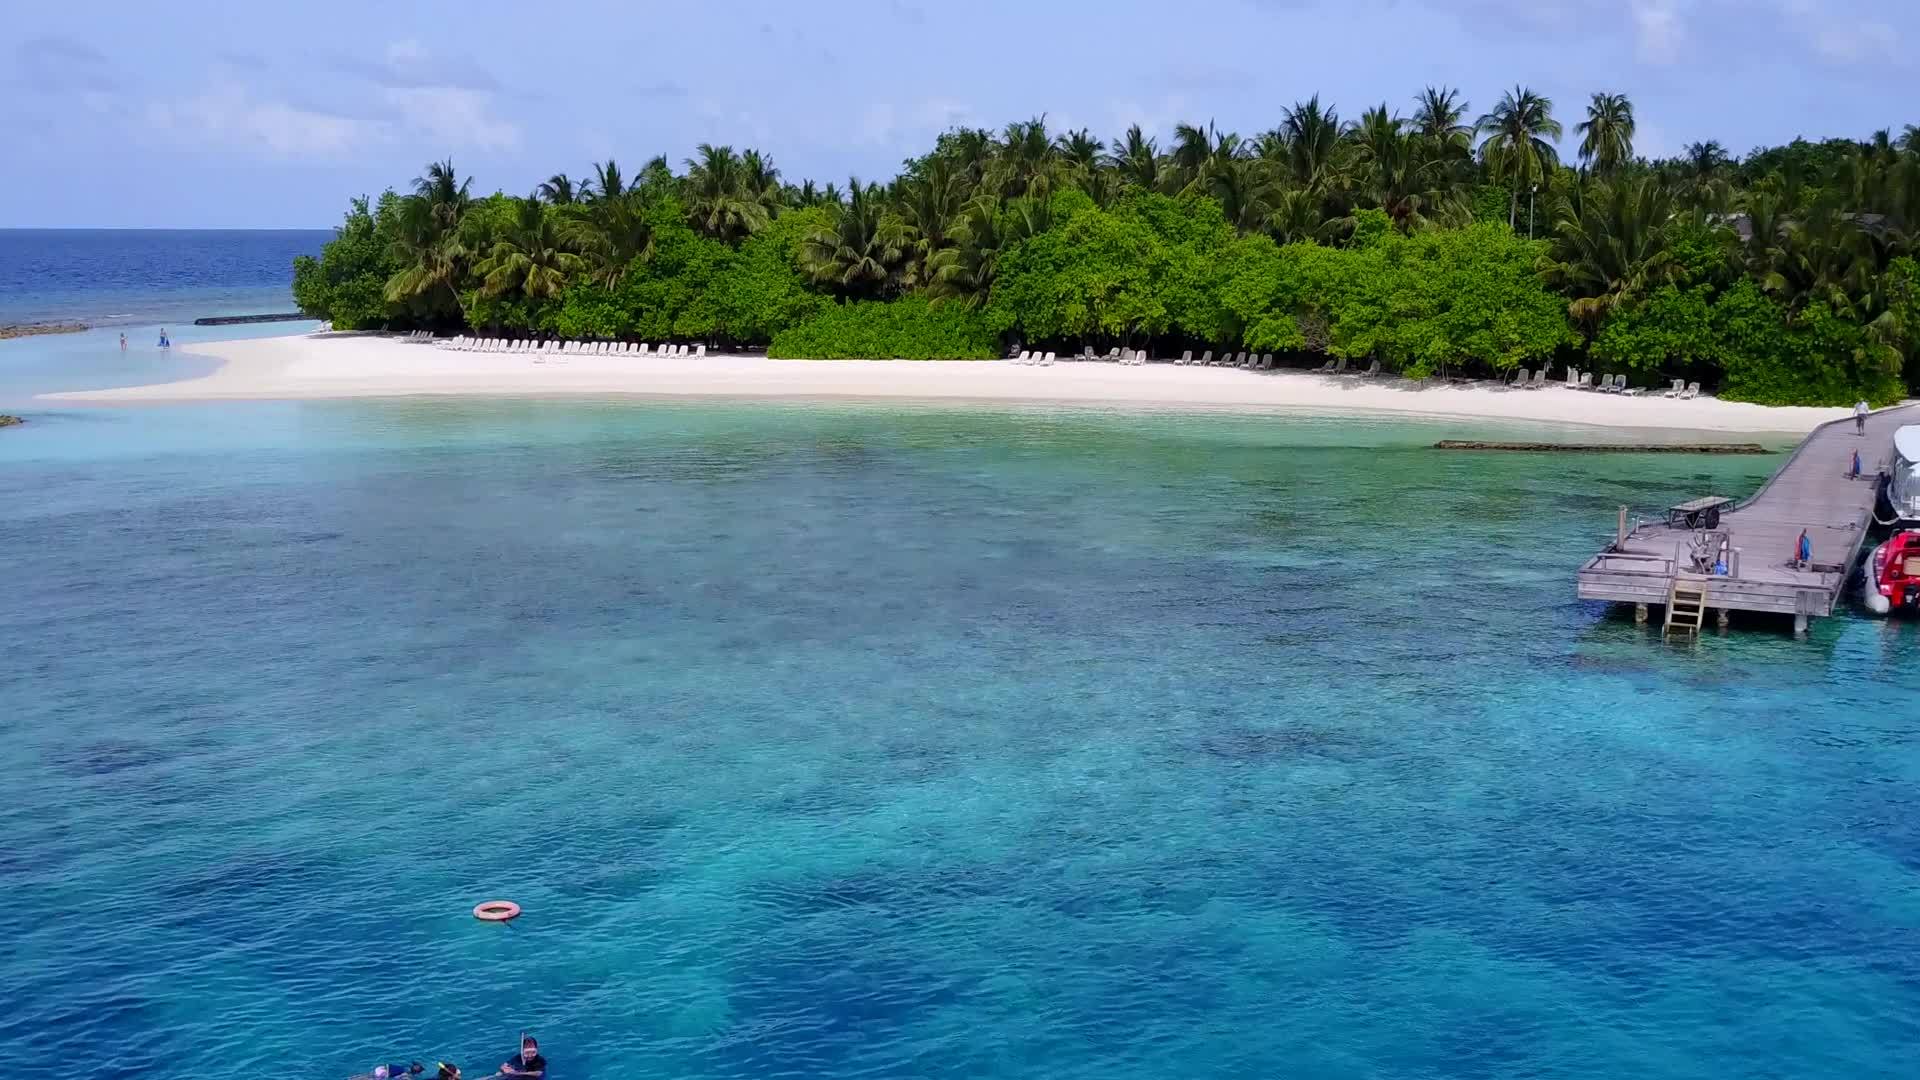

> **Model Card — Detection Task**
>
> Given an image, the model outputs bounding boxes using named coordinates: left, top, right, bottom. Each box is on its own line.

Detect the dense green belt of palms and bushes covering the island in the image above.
left=294, top=88, right=1920, bottom=404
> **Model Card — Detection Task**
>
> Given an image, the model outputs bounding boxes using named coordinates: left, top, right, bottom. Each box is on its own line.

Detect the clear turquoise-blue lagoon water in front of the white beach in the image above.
left=0, top=233, right=1920, bottom=1080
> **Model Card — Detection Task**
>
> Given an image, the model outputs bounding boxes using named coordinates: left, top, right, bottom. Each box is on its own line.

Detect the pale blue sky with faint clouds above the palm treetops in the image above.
left=0, top=0, right=1920, bottom=229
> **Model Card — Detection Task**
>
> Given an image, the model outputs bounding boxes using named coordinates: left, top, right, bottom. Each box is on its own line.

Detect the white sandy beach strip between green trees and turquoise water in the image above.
left=46, top=334, right=1849, bottom=434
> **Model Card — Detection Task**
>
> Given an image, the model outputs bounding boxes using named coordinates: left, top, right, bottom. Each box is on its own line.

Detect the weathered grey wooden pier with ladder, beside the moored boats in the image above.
left=1578, top=405, right=1920, bottom=632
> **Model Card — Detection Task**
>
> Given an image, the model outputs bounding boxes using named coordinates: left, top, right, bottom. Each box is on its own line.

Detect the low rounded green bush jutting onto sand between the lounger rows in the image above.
left=766, top=296, right=1000, bottom=359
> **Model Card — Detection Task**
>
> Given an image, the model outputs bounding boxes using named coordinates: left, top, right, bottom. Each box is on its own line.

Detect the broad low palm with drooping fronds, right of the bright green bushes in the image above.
left=1540, top=177, right=1680, bottom=327
